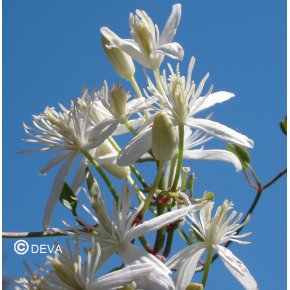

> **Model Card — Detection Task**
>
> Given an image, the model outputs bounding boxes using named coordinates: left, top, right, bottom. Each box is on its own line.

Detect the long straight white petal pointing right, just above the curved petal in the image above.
left=185, top=118, right=254, bottom=148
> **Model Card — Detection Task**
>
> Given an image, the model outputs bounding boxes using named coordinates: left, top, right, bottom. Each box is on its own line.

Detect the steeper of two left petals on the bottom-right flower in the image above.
left=174, top=249, right=206, bottom=290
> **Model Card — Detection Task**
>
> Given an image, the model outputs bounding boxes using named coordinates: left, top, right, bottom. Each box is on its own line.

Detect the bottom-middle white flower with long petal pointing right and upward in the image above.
left=55, top=181, right=207, bottom=290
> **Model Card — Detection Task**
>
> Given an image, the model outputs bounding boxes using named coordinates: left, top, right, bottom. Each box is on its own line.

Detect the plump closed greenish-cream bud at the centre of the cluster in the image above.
left=152, top=112, right=178, bottom=161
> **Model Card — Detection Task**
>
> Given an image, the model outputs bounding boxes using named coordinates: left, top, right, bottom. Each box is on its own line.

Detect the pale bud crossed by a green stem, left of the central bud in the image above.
left=95, top=140, right=130, bottom=179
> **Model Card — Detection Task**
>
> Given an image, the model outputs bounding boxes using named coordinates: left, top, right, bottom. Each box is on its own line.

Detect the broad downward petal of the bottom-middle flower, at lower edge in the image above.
left=118, top=243, right=174, bottom=290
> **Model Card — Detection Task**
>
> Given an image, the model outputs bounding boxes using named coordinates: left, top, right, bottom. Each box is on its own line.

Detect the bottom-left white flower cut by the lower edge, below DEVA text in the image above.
left=15, top=236, right=154, bottom=290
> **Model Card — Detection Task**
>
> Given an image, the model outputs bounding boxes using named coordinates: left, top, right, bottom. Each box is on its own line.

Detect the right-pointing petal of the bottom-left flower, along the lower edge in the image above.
left=94, top=263, right=154, bottom=290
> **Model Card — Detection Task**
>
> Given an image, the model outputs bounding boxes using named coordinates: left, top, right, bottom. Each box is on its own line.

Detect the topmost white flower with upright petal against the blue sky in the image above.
left=101, top=4, right=184, bottom=69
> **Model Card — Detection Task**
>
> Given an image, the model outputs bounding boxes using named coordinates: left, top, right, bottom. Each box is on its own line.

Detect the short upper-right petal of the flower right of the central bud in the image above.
left=191, top=91, right=235, bottom=114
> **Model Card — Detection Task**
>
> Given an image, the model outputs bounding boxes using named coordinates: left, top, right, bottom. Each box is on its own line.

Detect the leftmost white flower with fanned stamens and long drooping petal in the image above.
left=19, top=89, right=119, bottom=230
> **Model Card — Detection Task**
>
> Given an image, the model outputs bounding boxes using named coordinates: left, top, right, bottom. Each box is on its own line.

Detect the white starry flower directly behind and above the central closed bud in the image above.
left=117, top=57, right=254, bottom=166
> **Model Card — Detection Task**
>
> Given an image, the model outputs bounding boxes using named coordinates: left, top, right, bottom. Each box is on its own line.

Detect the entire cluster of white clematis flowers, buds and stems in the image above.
left=15, top=4, right=258, bottom=290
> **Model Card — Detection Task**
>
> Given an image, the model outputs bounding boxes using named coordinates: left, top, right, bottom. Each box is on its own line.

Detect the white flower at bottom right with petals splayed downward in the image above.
left=166, top=200, right=258, bottom=290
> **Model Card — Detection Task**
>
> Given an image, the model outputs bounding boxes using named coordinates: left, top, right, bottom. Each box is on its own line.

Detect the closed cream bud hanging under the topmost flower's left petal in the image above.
left=102, top=35, right=135, bottom=80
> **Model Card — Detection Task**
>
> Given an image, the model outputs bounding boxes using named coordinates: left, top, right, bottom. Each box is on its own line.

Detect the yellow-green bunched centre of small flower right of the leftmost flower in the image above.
left=109, top=85, right=129, bottom=118
